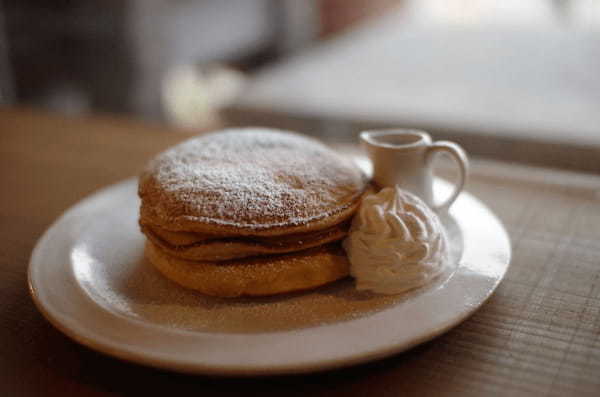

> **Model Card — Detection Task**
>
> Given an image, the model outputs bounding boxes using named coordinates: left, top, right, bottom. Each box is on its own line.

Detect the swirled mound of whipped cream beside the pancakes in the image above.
left=343, top=186, right=448, bottom=294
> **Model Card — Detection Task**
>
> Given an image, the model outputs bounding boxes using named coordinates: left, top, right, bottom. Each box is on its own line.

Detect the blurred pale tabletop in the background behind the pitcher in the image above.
left=228, top=10, right=600, bottom=172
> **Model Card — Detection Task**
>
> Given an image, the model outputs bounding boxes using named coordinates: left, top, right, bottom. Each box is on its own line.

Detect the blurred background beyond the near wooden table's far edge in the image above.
left=0, top=0, right=600, bottom=172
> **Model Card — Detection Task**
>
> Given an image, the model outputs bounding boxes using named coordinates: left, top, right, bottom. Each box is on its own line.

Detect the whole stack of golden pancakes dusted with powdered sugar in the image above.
left=138, top=128, right=368, bottom=297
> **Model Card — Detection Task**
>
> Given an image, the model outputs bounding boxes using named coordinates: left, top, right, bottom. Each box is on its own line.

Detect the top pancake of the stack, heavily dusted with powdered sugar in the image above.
left=139, top=128, right=367, bottom=235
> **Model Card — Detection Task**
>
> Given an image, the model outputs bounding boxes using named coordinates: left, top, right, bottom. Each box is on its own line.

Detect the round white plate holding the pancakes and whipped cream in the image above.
left=29, top=180, right=511, bottom=375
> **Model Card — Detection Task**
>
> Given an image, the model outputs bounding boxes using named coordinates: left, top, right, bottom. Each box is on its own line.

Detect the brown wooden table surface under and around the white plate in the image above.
left=0, top=109, right=600, bottom=396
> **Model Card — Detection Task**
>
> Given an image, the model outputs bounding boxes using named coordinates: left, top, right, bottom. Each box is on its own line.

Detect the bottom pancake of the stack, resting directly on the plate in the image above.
left=145, top=241, right=350, bottom=297
